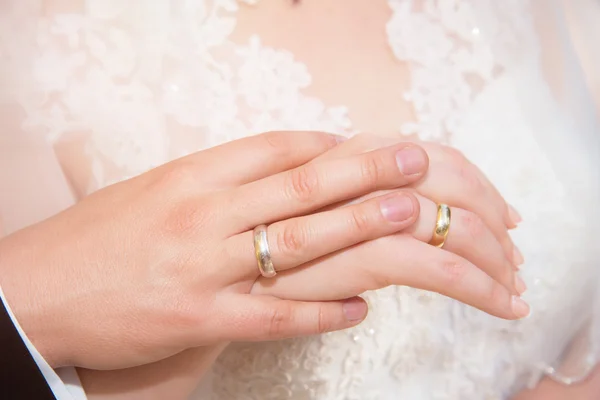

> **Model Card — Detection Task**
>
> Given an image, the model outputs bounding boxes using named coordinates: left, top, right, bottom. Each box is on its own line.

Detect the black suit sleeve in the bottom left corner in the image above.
left=0, top=299, right=56, bottom=400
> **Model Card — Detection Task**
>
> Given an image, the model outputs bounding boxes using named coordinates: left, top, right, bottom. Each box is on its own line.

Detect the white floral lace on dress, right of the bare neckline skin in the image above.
left=387, top=0, right=536, bottom=141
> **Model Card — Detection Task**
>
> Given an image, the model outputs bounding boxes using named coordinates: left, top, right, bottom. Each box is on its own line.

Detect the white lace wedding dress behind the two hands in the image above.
left=0, top=0, right=600, bottom=400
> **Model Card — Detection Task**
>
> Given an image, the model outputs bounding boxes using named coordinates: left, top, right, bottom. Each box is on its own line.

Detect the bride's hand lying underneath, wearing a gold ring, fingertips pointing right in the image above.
left=253, top=135, right=529, bottom=319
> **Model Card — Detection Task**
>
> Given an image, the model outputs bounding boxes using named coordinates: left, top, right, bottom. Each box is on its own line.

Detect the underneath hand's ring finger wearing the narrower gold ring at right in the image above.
left=404, top=196, right=526, bottom=294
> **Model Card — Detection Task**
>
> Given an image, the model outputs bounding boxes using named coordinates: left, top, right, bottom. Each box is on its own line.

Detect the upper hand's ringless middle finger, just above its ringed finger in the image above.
left=220, top=144, right=428, bottom=232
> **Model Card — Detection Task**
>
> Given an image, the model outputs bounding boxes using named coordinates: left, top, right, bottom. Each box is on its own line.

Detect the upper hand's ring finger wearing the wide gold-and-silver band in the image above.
left=226, top=191, right=419, bottom=279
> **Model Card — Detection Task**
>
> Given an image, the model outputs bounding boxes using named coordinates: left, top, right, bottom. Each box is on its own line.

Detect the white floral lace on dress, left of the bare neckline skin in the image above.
left=10, top=0, right=350, bottom=190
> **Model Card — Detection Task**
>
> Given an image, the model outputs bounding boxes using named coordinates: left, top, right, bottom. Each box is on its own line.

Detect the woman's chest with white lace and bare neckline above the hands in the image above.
left=14, top=0, right=540, bottom=192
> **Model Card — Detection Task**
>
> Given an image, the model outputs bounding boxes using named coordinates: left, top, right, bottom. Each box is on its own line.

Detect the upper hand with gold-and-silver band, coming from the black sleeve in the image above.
left=0, top=132, right=428, bottom=369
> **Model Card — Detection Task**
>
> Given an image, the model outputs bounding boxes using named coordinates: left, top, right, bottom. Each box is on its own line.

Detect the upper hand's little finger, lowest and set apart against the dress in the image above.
left=206, top=295, right=368, bottom=341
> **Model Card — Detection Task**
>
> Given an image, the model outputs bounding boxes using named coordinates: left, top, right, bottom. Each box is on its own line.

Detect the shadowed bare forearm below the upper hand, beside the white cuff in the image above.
left=78, top=345, right=226, bottom=400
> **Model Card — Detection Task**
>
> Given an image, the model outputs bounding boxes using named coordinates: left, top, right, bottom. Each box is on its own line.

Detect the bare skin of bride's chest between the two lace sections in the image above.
left=231, top=0, right=417, bottom=135
